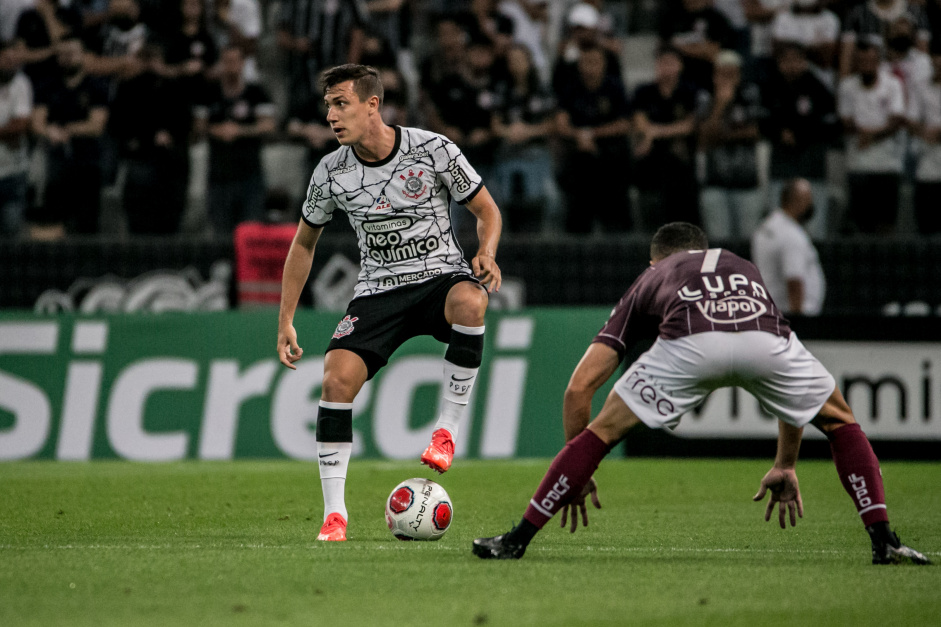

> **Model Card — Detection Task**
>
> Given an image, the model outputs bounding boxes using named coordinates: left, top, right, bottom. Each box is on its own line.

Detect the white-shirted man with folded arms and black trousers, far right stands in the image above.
left=837, top=44, right=905, bottom=233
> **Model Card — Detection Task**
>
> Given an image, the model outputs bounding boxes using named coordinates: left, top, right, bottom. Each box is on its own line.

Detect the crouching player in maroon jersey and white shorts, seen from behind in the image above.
left=473, top=222, right=930, bottom=564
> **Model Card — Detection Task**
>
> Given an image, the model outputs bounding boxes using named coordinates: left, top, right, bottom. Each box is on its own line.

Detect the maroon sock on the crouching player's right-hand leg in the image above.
left=827, top=423, right=889, bottom=527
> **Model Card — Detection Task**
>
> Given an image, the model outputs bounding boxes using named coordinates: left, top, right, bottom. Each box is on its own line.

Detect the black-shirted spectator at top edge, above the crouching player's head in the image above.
left=660, top=0, right=736, bottom=89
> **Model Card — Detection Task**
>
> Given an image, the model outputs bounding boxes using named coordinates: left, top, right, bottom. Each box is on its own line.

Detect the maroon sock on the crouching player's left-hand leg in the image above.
left=523, top=429, right=610, bottom=529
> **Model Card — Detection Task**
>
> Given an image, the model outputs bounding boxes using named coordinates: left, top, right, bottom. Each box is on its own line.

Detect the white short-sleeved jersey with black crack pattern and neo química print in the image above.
left=301, top=126, right=483, bottom=298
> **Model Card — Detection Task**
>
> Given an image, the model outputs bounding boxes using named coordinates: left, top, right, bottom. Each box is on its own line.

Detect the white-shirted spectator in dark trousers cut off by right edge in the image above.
left=908, top=47, right=941, bottom=235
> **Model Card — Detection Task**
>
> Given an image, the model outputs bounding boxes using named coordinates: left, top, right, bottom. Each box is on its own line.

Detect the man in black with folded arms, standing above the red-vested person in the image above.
left=198, top=46, right=276, bottom=235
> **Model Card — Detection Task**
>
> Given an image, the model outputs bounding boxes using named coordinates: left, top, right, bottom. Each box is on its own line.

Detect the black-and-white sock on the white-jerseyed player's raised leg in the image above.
left=435, top=324, right=486, bottom=439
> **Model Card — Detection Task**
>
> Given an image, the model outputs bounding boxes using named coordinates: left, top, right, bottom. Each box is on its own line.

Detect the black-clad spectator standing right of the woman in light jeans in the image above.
left=556, top=47, right=631, bottom=233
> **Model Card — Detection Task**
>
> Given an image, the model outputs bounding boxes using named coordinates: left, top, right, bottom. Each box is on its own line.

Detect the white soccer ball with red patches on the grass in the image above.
left=386, top=479, right=453, bottom=540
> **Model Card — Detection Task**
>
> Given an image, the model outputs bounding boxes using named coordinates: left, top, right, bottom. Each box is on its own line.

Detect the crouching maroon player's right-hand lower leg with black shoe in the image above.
left=813, top=388, right=928, bottom=564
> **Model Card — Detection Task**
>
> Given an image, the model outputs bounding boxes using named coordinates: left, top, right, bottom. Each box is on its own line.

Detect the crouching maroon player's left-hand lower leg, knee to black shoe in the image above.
left=473, top=391, right=640, bottom=559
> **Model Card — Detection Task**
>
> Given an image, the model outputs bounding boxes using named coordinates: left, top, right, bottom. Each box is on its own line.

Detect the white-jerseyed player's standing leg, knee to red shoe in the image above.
left=317, top=349, right=369, bottom=541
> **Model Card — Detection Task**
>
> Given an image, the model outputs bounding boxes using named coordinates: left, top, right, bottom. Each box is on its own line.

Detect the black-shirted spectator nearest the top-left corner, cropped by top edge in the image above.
left=14, top=0, right=82, bottom=87
